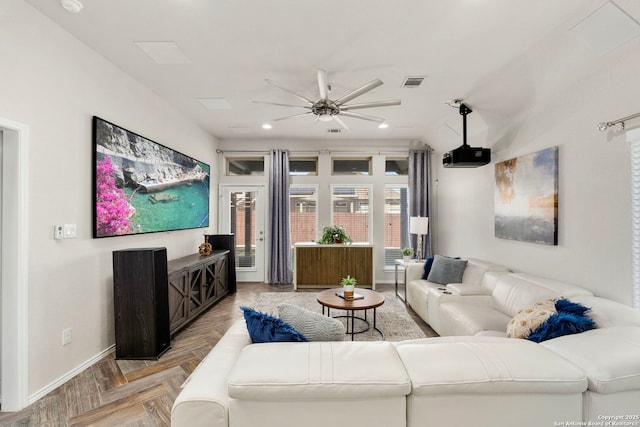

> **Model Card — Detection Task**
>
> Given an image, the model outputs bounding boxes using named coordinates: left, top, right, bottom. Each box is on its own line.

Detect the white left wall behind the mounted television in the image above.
left=0, top=0, right=217, bottom=402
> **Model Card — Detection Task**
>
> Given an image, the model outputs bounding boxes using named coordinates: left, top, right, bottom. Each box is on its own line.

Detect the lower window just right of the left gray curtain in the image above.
left=289, top=185, right=318, bottom=246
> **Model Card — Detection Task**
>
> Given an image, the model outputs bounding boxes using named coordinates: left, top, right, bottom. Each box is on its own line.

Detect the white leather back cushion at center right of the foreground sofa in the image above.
left=396, top=337, right=587, bottom=395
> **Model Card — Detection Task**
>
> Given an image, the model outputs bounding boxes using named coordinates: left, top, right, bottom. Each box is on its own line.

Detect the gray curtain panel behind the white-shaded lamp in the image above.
left=409, top=147, right=432, bottom=259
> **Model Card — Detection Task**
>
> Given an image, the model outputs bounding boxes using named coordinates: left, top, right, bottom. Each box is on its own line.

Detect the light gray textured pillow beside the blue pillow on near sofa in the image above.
left=278, top=303, right=345, bottom=341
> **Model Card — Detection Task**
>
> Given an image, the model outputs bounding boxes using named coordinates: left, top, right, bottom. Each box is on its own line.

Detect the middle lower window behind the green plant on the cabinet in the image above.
left=331, top=185, right=371, bottom=243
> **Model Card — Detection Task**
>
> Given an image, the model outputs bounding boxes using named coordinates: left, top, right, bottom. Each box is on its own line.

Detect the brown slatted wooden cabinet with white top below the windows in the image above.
left=294, top=243, right=376, bottom=289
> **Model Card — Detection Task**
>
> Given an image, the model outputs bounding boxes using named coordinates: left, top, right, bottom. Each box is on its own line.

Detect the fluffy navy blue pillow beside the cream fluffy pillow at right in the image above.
left=527, top=299, right=596, bottom=343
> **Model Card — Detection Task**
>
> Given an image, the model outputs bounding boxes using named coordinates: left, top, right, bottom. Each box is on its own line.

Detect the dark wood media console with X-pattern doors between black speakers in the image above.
left=168, top=250, right=229, bottom=336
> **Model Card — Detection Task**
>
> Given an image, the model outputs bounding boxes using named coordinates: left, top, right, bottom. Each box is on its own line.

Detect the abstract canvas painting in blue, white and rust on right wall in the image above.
left=495, top=147, right=558, bottom=245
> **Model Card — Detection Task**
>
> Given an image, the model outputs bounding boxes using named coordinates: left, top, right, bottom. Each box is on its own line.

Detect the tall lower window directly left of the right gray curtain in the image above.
left=384, top=185, right=410, bottom=268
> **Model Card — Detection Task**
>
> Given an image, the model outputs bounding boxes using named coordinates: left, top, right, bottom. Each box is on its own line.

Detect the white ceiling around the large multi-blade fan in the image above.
left=26, top=0, right=640, bottom=152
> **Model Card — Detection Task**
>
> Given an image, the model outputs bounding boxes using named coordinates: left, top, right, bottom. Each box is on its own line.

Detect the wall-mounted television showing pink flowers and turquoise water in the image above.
left=93, top=116, right=210, bottom=238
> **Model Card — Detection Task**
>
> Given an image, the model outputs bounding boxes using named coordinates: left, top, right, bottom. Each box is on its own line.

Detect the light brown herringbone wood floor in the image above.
left=0, top=283, right=435, bottom=427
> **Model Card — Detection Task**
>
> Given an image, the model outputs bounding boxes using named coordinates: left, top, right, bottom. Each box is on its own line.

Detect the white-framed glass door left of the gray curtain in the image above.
left=219, top=185, right=266, bottom=282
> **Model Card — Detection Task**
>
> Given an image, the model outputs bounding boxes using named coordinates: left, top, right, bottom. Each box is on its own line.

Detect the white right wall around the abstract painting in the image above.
left=434, top=36, right=640, bottom=304
